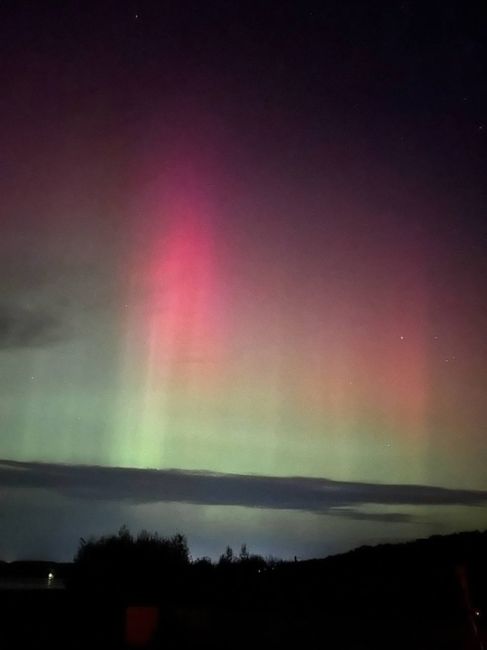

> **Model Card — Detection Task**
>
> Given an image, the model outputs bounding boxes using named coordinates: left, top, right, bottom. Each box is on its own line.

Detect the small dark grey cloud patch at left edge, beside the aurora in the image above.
left=0, top=304, right=63, bottom=350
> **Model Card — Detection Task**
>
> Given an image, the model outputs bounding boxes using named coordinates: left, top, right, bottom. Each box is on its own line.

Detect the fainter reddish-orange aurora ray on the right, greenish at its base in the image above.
left=305, top=237, right=432, bottom=482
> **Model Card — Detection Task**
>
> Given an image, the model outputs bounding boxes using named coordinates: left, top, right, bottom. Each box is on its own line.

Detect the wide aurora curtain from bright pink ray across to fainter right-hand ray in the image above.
left=107, top=170, right=458, bottom=482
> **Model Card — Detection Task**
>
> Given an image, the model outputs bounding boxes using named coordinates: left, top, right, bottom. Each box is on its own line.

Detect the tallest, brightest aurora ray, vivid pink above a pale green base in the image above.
left=114, top=162, right=225, bottom=467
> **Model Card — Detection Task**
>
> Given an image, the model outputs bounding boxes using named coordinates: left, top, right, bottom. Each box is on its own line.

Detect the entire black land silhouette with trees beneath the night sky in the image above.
left=0, top=527, right=487, bottom=650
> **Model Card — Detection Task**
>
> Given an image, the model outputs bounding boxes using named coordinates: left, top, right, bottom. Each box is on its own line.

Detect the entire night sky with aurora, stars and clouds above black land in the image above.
left=0, top=0, right=487, bottom=560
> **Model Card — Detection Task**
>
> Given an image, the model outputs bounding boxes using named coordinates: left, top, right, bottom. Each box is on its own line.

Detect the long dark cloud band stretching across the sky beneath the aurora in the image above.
left=0, top=461, right=487, bottom=523
